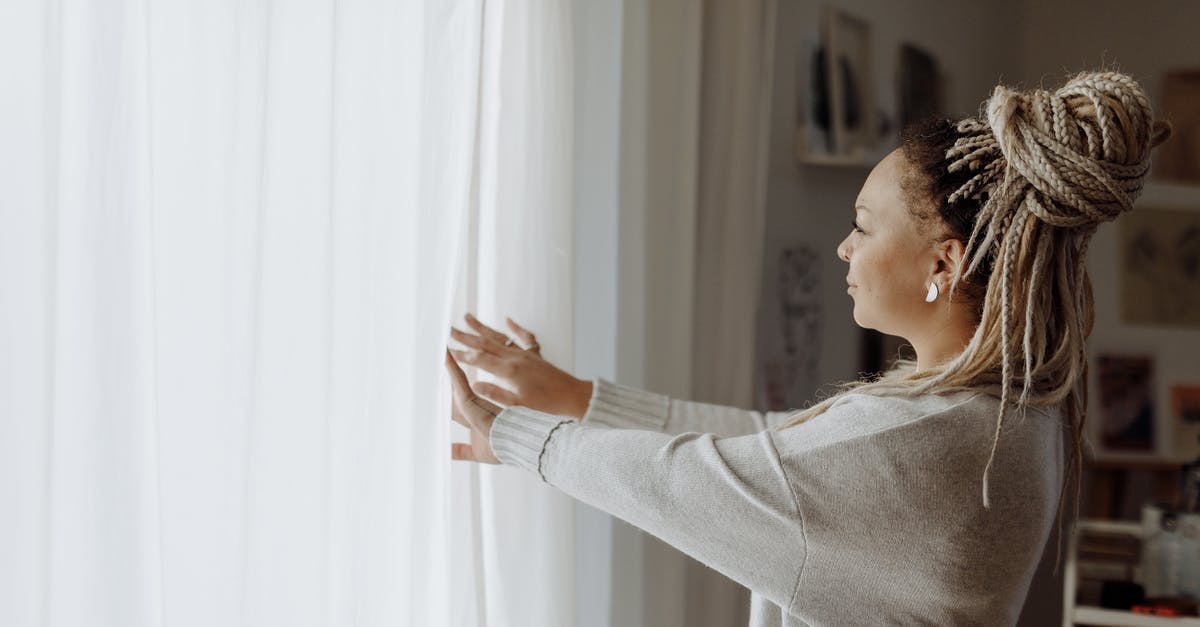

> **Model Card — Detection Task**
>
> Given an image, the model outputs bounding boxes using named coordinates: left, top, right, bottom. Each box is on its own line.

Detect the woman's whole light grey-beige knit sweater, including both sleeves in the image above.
left=491, top=378, right=1063, bottom=627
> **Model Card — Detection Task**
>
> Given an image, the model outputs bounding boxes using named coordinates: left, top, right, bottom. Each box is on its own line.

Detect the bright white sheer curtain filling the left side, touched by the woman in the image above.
left=0, top=0, right=570, bottom=627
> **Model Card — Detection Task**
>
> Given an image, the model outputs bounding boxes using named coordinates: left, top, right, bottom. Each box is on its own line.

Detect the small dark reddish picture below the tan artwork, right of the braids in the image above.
left=1097, top=354, right=1156, bottom=454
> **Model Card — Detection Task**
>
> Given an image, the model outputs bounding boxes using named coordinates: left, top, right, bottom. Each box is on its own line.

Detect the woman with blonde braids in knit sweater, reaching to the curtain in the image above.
left=446, top=72, right=1170, bottom=626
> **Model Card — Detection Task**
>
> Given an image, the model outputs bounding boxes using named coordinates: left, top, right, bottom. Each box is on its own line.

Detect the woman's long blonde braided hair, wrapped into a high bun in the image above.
left=778, top=72, right=1170, bottom=571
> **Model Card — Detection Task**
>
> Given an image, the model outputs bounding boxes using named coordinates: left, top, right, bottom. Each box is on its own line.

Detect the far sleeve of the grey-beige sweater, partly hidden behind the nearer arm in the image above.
left=581, top=377, right=792, bottom=436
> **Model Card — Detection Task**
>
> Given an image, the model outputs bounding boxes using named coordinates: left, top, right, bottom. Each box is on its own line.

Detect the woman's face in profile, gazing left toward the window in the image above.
left=838, top=149, right=946, bottom=339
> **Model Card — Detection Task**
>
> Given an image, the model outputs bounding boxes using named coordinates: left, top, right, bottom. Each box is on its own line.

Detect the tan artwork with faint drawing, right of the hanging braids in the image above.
left=1118, top=206, right=1200, bottom=328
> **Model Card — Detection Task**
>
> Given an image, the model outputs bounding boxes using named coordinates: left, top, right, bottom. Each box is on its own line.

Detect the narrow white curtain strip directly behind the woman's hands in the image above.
left=452, top=0, right=576, bottom=627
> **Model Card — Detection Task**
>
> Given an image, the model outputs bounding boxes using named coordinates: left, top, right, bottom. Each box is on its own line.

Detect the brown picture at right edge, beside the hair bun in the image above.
left=1151, top=70, right=1200, bottom=185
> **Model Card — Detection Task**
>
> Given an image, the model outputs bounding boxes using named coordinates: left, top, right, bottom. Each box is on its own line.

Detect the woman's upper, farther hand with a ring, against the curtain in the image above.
left=450, top=314, right=592, bottom=419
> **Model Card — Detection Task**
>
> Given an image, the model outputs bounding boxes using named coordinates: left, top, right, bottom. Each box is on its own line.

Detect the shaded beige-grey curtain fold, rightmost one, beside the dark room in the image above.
left=686, top=0, right=776, bottom=627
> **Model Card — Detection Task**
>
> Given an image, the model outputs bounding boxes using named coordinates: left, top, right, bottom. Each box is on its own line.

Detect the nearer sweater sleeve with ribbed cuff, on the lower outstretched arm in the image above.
left=490, top=401, right=808, bottom=609
